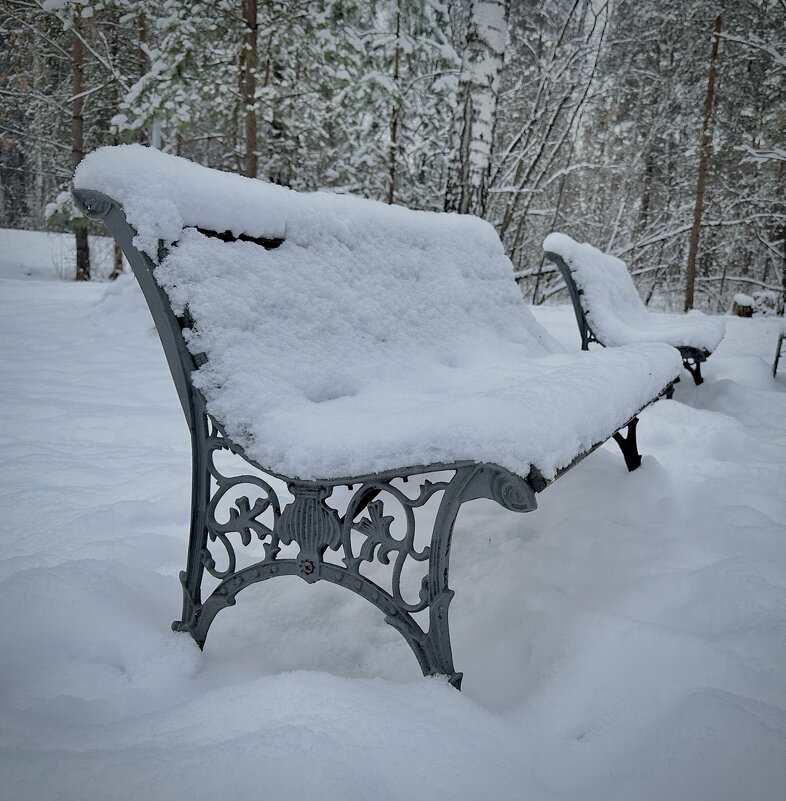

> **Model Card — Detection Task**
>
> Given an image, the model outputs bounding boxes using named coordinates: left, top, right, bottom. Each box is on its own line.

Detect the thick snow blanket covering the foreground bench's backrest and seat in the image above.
left=75, top=146, right=681, bottom=479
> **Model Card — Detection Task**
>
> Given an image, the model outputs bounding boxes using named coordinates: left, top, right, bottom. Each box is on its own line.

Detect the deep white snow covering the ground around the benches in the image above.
left=0, top=232, right=786, bottom=801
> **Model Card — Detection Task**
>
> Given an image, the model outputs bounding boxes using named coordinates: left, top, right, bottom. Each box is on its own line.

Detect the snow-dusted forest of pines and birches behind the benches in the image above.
left=0, top=0, right=786, bottom=313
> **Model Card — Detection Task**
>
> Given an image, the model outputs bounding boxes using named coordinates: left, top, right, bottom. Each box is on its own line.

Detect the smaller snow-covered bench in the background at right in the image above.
left=543, top=233, right=726, bottom=384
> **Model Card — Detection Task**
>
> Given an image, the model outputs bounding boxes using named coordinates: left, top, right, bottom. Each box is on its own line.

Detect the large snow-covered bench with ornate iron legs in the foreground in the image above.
left=74, top=146, right=680, bottom=686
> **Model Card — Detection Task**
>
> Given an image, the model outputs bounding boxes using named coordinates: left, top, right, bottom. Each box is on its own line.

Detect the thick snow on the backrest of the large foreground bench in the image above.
left=74, top=145, right=562, bottom=476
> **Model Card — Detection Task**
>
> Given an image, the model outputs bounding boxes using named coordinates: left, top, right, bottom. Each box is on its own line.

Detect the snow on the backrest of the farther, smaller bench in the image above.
left=543, top=233, right=648, bottom=345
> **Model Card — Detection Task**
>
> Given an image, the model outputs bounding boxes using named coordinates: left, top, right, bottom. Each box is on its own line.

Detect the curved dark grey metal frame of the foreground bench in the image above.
left=73, top=190, right=656, bottom=688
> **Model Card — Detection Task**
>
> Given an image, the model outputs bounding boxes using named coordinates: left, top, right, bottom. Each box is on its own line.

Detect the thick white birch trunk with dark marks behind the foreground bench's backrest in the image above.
left=445, top=0, right=510, bottom=215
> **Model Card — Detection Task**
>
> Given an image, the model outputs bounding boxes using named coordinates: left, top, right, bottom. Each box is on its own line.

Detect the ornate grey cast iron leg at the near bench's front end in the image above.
left=172, top=412, right=537, bottom=688
